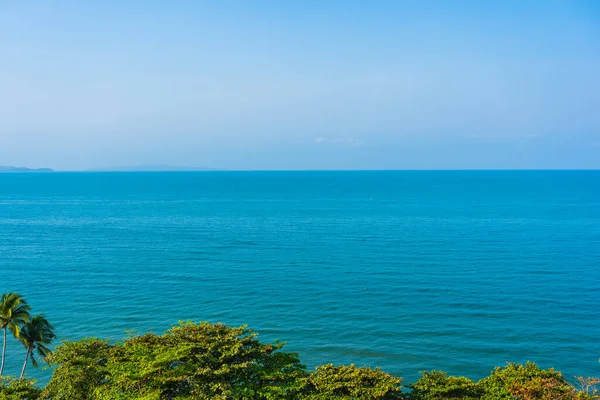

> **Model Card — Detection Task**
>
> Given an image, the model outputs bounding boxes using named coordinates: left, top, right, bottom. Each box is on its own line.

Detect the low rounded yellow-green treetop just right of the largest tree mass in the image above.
left=301, top=364, right=402, bottom=400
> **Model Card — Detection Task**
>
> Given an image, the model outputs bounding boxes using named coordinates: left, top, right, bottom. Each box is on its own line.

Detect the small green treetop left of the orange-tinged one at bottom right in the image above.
left=408, top=371, right=483, bottom=400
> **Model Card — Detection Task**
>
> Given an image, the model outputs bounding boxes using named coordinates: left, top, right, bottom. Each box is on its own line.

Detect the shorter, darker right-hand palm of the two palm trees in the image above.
left=19, top=315, right=56, bottom=379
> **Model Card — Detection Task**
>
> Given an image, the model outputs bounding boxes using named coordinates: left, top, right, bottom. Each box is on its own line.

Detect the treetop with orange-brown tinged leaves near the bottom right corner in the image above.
left=479, top=362, right=581, bottom=400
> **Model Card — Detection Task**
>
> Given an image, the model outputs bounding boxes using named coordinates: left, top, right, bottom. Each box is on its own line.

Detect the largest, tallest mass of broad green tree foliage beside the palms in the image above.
left=44, top=323, right=306, bottom=400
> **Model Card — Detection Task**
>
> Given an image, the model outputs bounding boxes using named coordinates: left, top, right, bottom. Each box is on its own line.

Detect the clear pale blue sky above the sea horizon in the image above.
left=0, top=0, right=600, bottom=170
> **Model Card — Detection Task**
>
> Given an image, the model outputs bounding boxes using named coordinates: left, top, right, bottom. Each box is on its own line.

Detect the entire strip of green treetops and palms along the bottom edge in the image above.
left=0, top=293, right=600, bottom=400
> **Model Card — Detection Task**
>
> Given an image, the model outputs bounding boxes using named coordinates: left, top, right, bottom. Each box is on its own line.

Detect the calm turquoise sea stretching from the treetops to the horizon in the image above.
left=0, top=171, right=600, bottom=382
